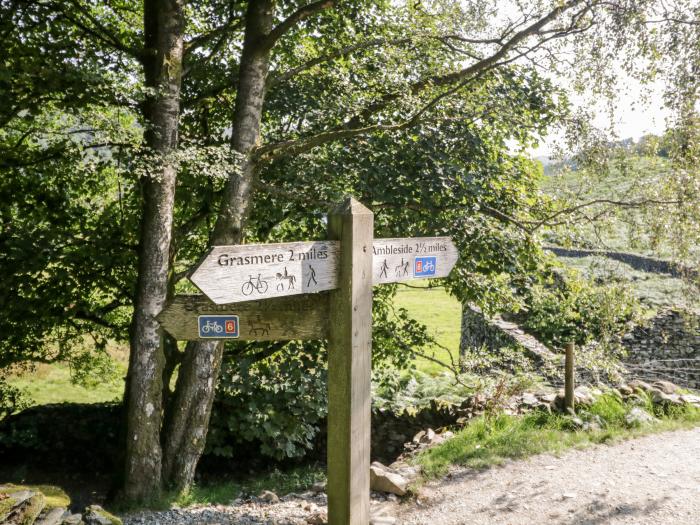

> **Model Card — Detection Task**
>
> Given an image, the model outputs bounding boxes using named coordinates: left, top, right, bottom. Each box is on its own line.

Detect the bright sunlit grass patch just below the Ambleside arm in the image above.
left=396, top=283, right=462, bottom=375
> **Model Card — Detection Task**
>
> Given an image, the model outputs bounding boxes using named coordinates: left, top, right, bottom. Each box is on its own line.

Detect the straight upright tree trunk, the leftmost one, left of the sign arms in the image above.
left=124, top=0, right=184, bottom=501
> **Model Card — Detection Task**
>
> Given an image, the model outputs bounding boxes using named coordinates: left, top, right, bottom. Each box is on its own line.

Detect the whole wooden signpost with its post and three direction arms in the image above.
left=158, top=197, right=457, bottom=525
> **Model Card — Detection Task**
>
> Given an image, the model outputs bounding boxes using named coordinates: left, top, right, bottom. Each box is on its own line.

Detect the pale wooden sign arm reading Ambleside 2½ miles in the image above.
left=372, top=237, right=459, bottom=284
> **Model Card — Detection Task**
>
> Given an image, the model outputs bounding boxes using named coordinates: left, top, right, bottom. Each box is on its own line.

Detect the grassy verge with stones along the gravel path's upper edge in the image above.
left=416, top=394, right=700, bottom=478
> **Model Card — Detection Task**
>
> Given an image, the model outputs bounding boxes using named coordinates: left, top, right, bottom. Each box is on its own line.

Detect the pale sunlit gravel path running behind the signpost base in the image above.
left=125, top=428, right=700, bottom=525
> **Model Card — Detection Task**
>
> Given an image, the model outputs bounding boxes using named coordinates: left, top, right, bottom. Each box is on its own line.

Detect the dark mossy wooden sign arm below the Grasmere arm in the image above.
left=157, top=293, right=329, bottom=341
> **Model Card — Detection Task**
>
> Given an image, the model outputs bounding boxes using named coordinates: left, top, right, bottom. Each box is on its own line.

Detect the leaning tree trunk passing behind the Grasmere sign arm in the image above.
left=164, top=0, right=273, bottom=490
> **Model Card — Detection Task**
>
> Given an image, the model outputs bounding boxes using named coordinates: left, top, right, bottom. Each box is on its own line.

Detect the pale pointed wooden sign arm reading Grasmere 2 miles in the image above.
left=190, top=241, right=338, bottom=304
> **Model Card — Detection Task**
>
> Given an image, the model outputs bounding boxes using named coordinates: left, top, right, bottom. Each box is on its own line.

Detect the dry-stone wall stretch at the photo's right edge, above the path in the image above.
left=622, top=309, right=700, bottom=389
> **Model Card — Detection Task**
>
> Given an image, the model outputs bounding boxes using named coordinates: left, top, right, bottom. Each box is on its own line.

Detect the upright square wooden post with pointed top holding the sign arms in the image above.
left=327, top=197, right=374, bottom=525
